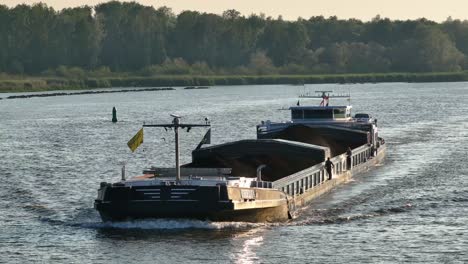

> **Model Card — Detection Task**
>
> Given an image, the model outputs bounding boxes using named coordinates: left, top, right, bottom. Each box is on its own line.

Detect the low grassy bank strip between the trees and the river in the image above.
left=0, top=71, right=468, bottom=92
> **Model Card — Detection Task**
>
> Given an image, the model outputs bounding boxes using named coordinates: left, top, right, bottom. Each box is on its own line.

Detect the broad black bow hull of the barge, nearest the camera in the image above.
left=94, top=184, right=288, bottom=222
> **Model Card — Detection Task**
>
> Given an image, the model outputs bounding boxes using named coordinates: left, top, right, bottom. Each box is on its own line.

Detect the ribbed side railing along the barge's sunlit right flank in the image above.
left=272, top=144, right=372, bottom=196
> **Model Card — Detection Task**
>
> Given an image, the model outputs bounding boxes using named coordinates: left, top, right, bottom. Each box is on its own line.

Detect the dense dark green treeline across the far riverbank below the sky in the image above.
left=0, top=1, right=468, bottom=75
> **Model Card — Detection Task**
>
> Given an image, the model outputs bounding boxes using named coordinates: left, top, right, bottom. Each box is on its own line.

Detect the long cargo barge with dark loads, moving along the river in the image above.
left=94, top=91, right=386, bottom=222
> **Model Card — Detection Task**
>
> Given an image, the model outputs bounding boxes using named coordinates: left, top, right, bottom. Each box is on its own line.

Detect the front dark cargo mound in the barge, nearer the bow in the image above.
left=184, top=139, right=330, bottom=181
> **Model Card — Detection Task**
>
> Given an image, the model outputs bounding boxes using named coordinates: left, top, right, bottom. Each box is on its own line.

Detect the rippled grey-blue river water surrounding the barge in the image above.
left=0, top=83, right=468, bottom=263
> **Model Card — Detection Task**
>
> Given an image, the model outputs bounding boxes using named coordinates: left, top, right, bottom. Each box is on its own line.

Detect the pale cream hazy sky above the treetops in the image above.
left=0, top=0, right=468, bottom=22
